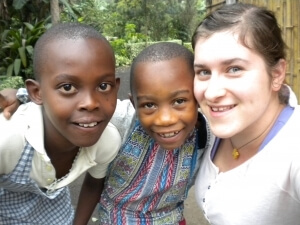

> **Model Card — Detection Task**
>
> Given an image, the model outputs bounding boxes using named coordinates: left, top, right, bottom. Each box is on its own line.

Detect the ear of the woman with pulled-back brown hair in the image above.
left=271, top=59, right=286, bottom=91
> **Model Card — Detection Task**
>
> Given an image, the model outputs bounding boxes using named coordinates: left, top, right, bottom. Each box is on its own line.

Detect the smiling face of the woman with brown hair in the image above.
left=194, top=32, right=278, bottom=138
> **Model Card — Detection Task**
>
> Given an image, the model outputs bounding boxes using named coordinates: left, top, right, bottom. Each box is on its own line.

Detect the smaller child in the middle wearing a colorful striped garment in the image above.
left=98, top=43, right=207, bottom=225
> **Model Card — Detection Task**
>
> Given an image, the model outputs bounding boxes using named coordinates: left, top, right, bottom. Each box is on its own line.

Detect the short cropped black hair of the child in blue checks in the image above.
left=33, top=23, right=114, bottom=80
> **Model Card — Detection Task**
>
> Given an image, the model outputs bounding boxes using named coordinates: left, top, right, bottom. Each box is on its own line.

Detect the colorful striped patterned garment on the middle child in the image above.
left=99, top=122, right=203, bottom=225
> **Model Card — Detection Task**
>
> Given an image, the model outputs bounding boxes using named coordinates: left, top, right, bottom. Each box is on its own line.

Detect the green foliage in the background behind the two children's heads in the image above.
left=0, top=0, right=205, bottom=74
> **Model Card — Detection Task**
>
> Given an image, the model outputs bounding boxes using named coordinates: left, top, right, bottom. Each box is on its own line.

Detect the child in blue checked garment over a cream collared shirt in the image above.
left=0, top=24, right=121, bottom=225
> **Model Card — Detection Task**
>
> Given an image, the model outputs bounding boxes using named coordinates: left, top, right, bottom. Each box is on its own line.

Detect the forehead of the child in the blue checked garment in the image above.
left=39, top=39, right=115, bottom=80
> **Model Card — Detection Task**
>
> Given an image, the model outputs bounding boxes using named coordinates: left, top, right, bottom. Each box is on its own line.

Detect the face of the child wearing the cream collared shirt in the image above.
left=31, top=39, right=119, bottom=148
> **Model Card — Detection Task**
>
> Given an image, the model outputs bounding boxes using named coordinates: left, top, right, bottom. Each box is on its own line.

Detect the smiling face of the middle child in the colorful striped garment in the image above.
left=132, top=58, right=197, bottom=149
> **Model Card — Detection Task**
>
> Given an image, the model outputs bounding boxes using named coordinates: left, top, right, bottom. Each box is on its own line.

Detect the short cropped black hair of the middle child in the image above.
left=130, top=42, right=194, bottom=93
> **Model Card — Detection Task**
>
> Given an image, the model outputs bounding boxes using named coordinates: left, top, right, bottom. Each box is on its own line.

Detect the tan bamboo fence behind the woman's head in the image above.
left=206, top=0, right=300, bottom=102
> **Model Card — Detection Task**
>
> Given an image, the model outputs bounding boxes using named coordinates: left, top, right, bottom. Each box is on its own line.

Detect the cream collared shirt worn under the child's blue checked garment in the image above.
left=0, top=103, right=121, bottom=189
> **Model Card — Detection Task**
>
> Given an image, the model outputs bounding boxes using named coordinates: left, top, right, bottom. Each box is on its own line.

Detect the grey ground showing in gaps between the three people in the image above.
left=70, top=67, right=208, bottom=225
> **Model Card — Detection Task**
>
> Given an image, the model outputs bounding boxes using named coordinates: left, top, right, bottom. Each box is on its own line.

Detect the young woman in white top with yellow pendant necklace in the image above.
left=193, top=4, right=300, bottom=225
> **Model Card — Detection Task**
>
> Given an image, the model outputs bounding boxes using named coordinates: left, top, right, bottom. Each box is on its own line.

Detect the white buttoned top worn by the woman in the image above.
left=195, top=106, right=300, bottom=225
